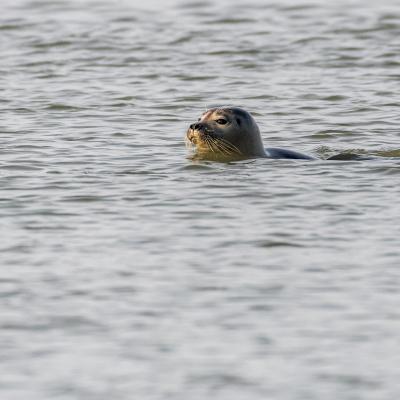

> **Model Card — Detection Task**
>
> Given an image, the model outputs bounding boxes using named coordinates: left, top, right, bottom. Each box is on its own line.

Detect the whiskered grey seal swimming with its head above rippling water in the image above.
left=186, top=107, right=314, bottom=160
